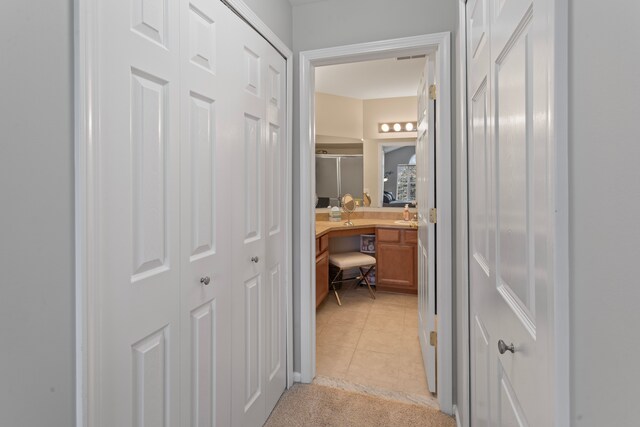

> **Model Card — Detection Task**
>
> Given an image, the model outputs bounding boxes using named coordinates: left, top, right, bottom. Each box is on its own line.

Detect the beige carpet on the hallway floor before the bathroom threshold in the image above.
left=265, top=384, right=456, bottom=427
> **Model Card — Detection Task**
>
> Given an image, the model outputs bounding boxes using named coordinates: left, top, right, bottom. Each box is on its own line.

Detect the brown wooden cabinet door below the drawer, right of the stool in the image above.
left=377, top=242, right=417, bottom=292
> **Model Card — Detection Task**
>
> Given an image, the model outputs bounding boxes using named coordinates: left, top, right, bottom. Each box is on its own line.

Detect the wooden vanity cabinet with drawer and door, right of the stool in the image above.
left=376, top=227, right=418, bottom=294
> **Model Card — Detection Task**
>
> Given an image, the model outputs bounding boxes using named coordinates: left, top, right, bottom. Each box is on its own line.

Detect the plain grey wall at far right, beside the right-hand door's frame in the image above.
left=569, top=0, right=640, bottom=427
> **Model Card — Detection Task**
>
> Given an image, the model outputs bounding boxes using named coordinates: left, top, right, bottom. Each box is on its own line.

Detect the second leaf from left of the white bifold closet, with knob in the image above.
left=180, top=0, right=233, bottom=427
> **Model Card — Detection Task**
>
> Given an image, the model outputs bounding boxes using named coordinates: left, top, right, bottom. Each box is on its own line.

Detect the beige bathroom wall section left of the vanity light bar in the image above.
left=316, top=92, right=363, bottom=142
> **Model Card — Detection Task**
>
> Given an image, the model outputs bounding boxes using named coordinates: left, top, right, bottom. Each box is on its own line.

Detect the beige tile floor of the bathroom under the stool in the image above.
left=316, top=287, right=431, bottom=397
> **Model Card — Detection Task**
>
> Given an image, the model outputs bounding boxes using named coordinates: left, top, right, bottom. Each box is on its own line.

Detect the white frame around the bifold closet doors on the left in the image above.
left=74, top=0, right=293, bottom=427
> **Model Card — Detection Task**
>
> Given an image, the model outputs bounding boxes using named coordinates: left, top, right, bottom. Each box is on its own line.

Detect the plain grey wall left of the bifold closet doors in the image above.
left=0, top=0, right=74, bottom=427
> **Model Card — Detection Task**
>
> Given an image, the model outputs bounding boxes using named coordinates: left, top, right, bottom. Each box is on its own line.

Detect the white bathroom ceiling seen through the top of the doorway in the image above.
left=314, top=56, right=426, bottom=99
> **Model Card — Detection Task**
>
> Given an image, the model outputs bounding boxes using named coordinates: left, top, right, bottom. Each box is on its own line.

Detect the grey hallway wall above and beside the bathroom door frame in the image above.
left=293, top=0, right=458, bottom=404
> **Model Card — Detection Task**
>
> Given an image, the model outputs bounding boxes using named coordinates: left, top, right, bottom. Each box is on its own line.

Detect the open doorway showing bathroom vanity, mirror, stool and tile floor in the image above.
left=315, top=54, right=428, bottom=404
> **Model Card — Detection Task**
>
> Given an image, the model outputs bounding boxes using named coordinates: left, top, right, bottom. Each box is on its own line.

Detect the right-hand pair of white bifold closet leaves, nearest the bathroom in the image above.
left=228, top=13, right=286, bottom=426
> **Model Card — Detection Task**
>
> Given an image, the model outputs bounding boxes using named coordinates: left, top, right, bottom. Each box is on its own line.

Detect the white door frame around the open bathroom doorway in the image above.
left=298, top=32, right=453, bottom=414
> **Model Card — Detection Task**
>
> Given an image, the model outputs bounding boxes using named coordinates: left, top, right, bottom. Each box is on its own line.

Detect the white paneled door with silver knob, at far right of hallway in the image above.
left=467, top=0, right=553, bottom=427
